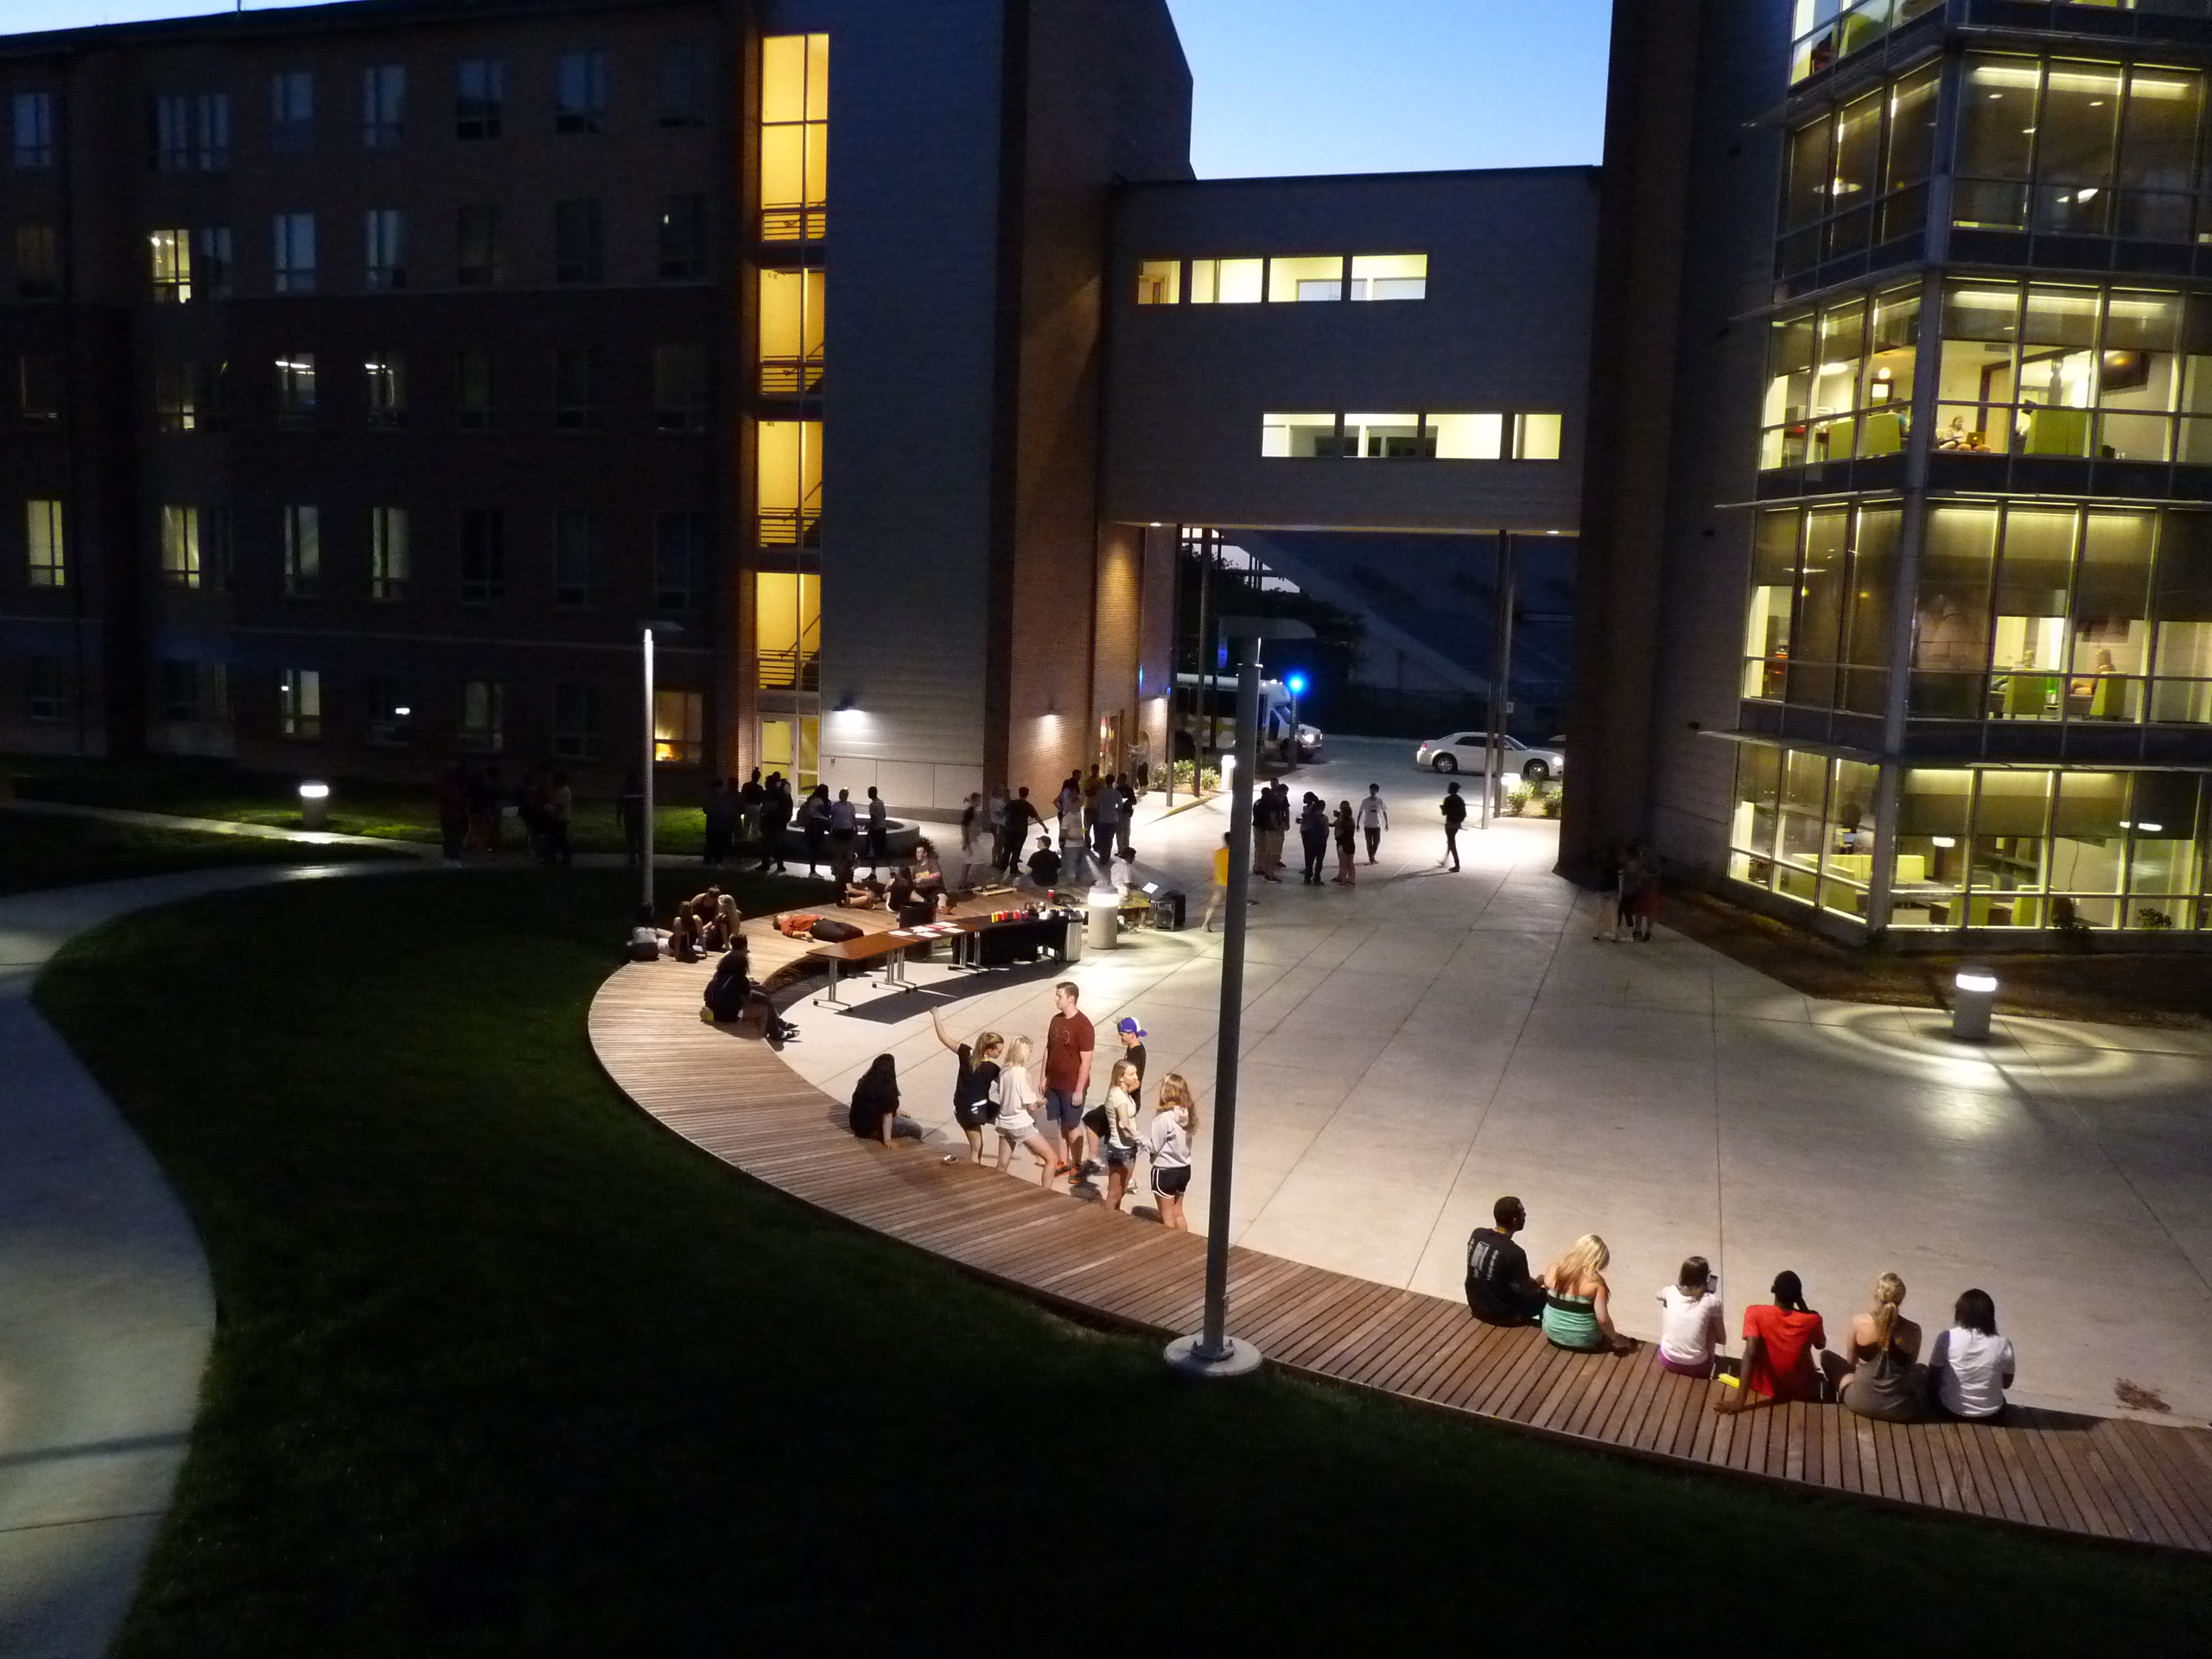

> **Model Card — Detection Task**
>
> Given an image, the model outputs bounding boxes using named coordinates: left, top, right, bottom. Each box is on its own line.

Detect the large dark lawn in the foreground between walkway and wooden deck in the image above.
left=38, top=869, right=2212, bottom=1659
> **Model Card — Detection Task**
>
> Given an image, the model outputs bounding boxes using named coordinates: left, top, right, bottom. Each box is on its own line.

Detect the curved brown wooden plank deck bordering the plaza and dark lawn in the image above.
left=591, top=946, right=2212, bottom=1553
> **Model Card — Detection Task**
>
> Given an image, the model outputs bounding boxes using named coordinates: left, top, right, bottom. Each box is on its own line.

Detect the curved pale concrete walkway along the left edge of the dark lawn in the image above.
left=0, top=861, right=389, bottom=1659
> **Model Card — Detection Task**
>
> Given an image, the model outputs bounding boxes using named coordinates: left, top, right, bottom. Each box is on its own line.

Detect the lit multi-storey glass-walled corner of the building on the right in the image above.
left=1727, top=0, right=2212, bottom=936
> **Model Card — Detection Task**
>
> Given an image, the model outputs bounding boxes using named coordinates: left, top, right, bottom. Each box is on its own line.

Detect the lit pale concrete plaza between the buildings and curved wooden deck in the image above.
left=785, top=743, right=2212, bottom=1421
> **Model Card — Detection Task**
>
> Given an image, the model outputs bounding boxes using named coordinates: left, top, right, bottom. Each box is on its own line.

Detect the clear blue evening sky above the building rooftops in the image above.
left=0, top=0, right=1611, bottom=179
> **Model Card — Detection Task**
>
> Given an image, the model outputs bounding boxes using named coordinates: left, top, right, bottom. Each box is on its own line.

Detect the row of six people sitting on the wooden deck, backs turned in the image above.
left=1466, top=1197, right=2015, bottom=1422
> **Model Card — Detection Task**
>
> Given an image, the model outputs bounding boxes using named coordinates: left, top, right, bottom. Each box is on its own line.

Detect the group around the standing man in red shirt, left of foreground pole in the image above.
left=847, top=980, right=1199, bottom=1230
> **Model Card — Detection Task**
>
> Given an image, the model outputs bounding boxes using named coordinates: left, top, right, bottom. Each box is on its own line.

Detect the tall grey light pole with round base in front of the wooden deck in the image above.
left=1168, top=617, right=1314, bottom=1376
